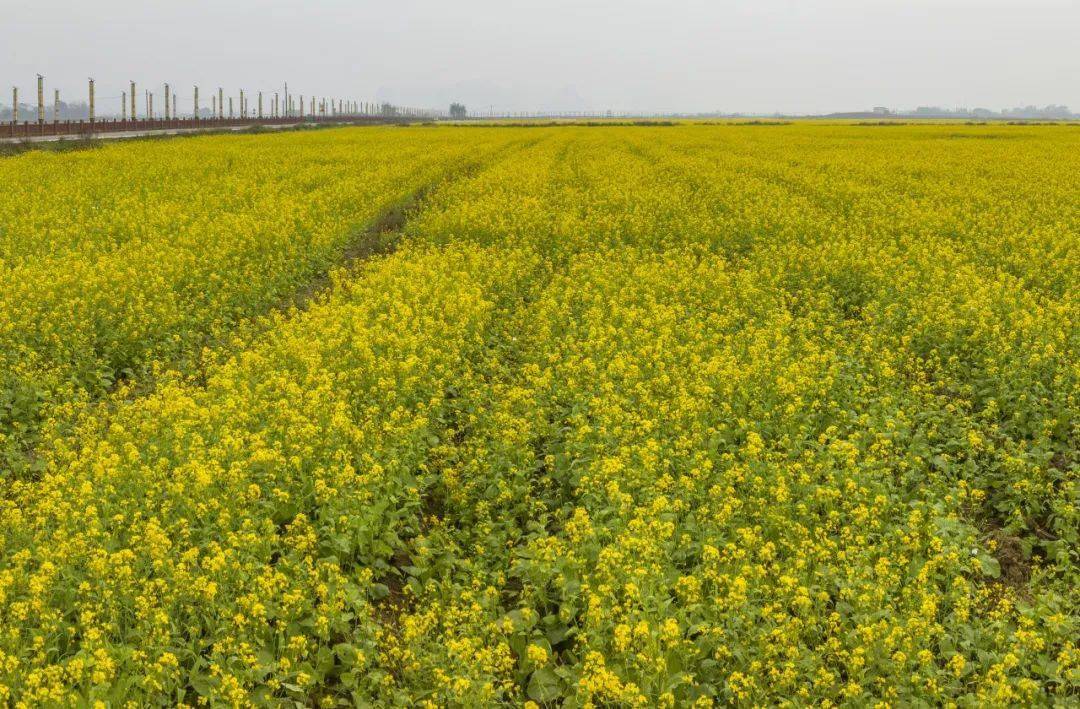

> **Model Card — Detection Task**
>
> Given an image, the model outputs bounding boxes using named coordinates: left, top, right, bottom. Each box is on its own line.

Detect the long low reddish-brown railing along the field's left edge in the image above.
left=0, top=115, right=426, bottom=139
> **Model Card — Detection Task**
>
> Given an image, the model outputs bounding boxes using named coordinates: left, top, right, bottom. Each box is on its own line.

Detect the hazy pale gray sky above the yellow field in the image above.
left=0, top=0, right=1080, bottom=113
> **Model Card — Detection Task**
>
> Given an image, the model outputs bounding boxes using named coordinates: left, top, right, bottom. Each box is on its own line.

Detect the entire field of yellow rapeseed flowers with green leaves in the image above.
left=0, top=123, right=1080, bottom=707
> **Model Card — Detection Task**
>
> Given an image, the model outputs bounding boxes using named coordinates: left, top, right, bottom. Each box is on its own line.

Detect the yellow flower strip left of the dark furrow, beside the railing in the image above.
left=0, top=130, right=522, bottom=471
